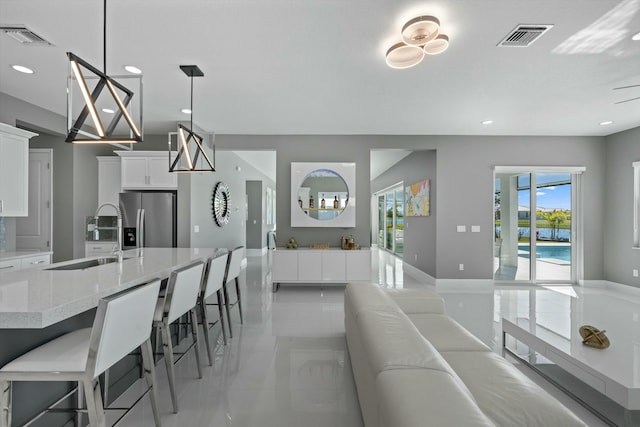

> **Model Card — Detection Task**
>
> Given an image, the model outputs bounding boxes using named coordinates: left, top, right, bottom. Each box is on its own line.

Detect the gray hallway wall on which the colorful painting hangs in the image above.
left=371, top=150, right=438, bottom=277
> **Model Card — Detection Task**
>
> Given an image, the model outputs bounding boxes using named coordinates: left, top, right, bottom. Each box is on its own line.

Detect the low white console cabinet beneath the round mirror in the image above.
left=271, top=248, right=371, bottom=290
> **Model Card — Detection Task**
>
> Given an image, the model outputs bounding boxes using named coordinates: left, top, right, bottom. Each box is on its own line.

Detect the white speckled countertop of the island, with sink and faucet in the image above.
left=0, top=248, right=226, bottom=329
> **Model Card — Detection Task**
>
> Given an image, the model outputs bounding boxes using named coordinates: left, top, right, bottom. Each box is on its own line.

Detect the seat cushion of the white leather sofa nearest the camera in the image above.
left=441, top=351, right=585, bottom=427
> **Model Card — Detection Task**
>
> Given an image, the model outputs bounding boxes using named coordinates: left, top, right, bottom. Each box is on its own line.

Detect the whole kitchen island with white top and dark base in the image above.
left=0, top=248, right=227, bottom=426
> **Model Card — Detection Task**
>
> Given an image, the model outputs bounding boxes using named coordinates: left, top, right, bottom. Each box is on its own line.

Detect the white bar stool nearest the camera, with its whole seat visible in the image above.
left=0, top=280, right=161, bottom=427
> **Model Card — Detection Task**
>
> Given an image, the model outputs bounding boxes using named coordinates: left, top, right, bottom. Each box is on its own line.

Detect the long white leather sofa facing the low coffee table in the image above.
left=344, top=283, right=585, bottom=427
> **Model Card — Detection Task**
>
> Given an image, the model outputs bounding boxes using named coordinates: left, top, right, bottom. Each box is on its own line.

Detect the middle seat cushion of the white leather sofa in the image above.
left=408, top=313, right=491, bottom=351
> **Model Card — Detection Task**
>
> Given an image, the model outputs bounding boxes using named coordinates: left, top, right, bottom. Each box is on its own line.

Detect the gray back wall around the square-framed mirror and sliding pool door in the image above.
left=216, top=135, right=605, bottom=279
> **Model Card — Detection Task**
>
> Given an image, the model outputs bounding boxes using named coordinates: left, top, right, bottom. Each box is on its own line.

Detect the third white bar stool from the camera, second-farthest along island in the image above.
left=198, top=252, right=229, bottom=366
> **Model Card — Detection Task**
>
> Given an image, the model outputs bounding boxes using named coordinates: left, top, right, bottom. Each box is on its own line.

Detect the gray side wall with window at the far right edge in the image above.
left=603, top=128, right=640, bottom=287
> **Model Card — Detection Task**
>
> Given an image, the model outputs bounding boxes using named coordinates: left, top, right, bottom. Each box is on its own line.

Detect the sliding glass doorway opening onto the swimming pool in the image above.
left=493, top=167, right=583, bottom=283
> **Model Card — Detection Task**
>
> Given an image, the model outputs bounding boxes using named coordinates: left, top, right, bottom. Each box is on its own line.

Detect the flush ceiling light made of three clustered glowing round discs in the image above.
left=385, top=15, right=449, bottom=69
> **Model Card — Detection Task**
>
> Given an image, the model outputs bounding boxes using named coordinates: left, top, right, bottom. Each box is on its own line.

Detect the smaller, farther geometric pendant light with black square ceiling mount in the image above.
left=169, top=65, right=216, bottom=172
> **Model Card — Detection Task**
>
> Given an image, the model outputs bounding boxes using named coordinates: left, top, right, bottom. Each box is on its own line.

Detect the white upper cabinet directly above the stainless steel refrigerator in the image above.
left=116, top=151, right=178, bottom=190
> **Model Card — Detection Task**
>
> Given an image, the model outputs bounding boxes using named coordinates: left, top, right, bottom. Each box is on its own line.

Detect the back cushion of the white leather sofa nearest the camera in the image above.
left=376, top=369, right=494, bottom=427
